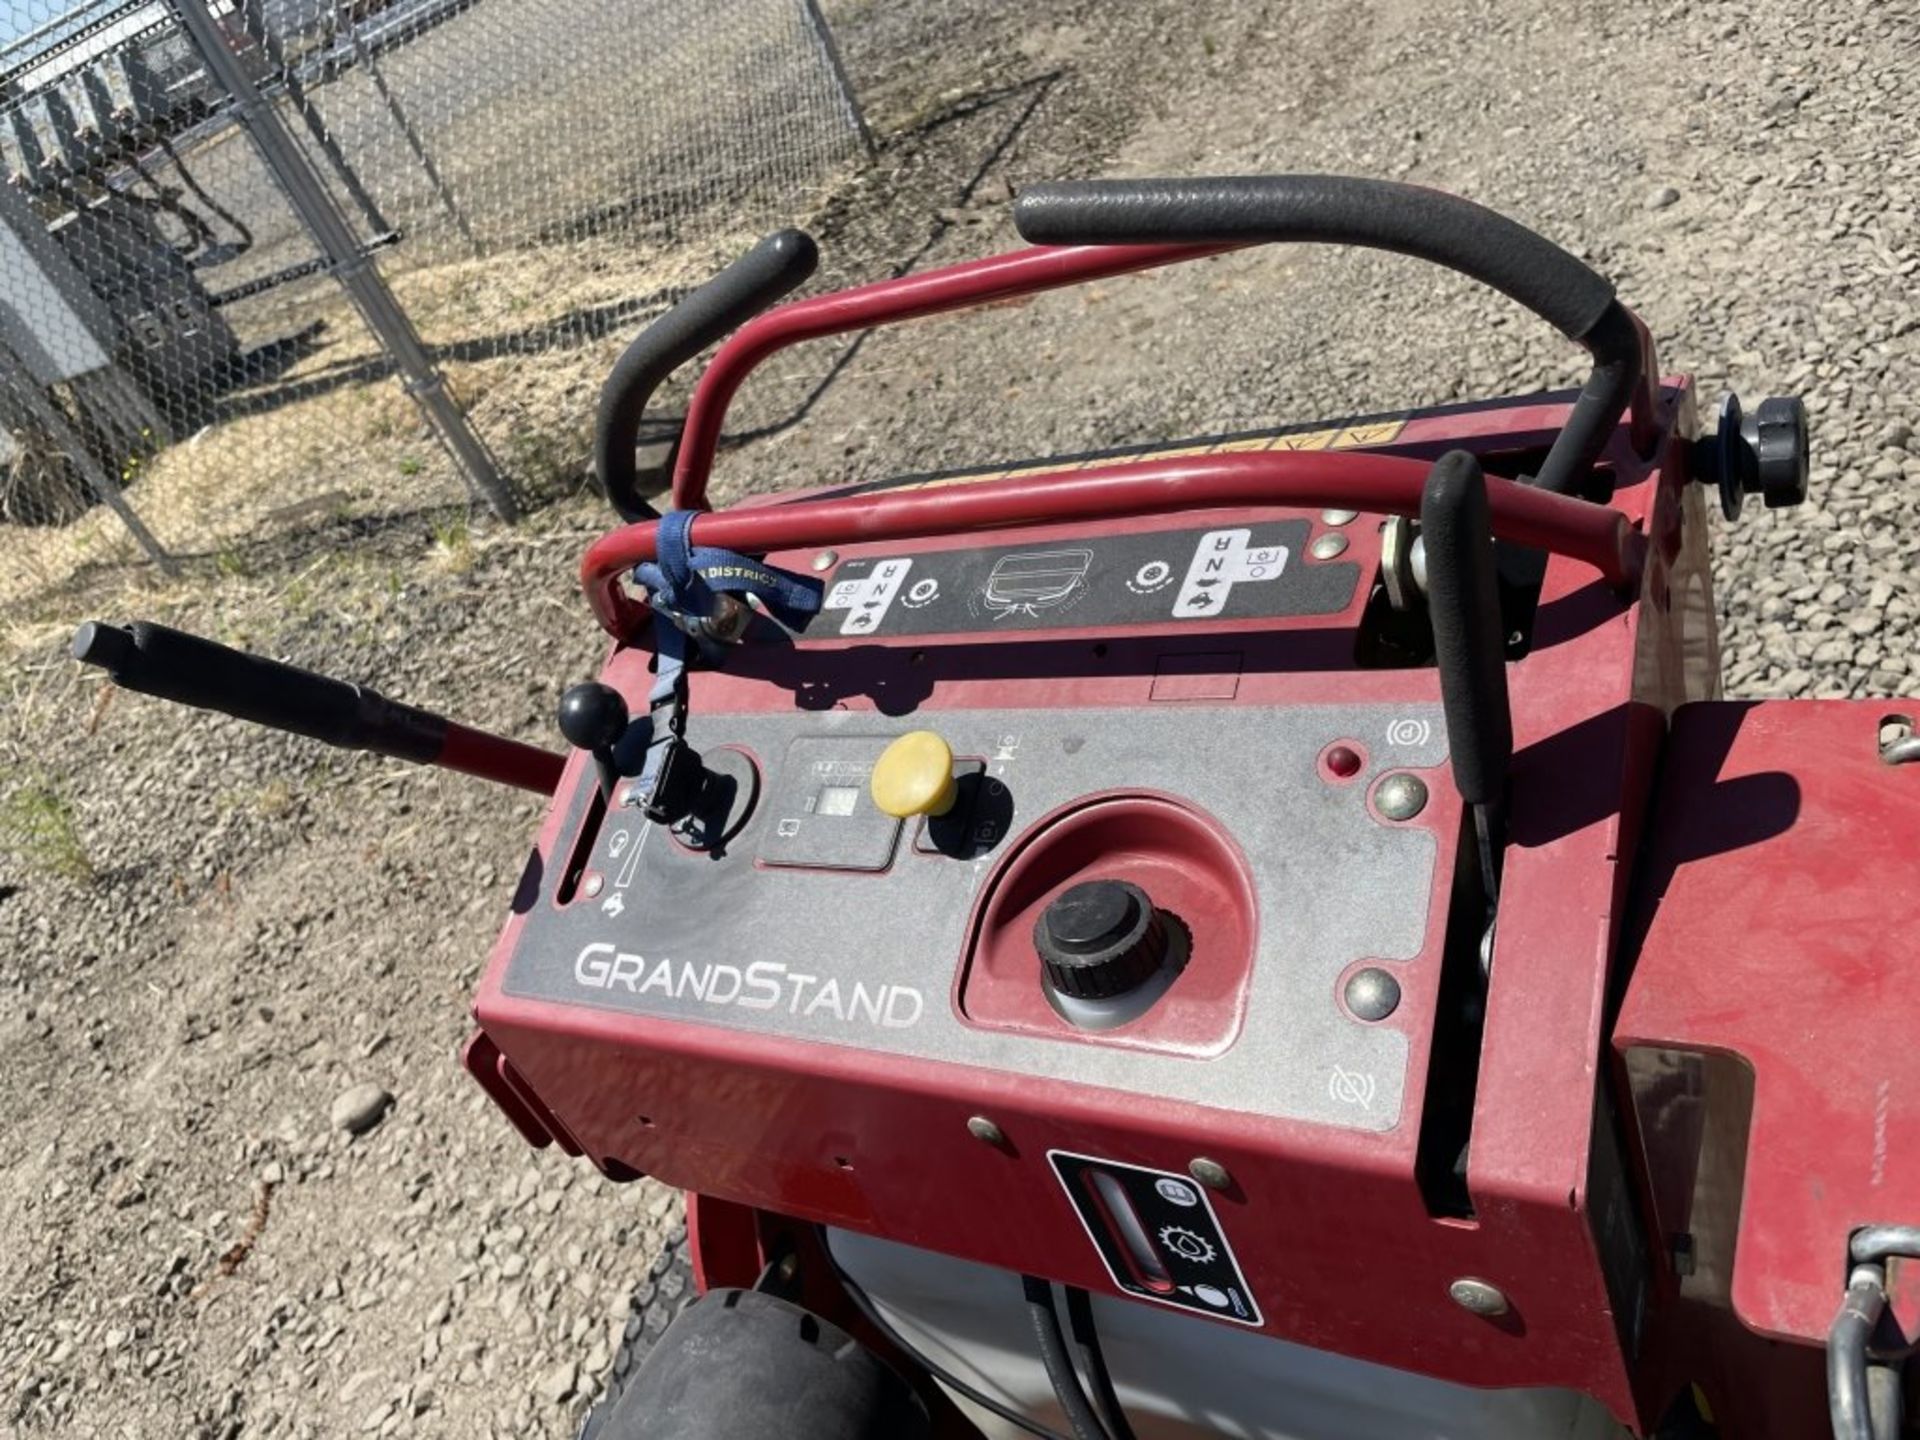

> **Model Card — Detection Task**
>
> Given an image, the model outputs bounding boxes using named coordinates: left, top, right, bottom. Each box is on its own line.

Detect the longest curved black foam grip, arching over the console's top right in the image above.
left=1014, top=175, right=1644, bottom=495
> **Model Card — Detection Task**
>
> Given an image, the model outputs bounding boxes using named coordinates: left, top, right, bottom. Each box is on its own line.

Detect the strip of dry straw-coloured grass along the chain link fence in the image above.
left=0, top=232, right=779, bottom=653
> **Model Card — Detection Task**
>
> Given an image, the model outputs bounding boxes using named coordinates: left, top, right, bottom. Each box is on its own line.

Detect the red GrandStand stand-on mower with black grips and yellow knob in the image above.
left=75, top=177, right=1920, bottom=1440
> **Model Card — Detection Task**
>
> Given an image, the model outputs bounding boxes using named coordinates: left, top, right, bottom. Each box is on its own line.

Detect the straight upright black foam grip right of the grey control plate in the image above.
left=1421, top=449, right=1513, bottom=804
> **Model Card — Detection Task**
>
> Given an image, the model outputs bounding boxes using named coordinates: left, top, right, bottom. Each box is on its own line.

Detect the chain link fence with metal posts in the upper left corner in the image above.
left=0, top=0, right=870, bottom=609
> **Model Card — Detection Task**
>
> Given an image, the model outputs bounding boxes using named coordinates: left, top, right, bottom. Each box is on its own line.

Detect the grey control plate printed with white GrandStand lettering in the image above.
left=503, top=705, right=1446, bottom=1131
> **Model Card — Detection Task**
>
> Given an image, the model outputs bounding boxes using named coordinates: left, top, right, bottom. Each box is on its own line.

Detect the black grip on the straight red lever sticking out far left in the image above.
left=73, top=620, right=447, bottom=764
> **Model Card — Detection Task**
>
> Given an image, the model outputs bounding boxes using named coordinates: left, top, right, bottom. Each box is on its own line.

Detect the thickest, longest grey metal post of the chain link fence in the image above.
left=169, top=0, right=520, bottom=520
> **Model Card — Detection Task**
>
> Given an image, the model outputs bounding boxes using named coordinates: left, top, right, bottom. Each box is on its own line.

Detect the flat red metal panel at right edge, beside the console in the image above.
left=1615, top=701, right=1920, bottom=1436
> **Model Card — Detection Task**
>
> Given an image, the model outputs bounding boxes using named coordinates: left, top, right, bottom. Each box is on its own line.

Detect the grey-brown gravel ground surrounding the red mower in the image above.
left=0, top=0, right=1920, bottom=1438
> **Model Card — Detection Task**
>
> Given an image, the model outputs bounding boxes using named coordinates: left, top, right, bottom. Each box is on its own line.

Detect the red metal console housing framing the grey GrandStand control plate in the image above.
left=474, top=382, right=1715, bottom=1419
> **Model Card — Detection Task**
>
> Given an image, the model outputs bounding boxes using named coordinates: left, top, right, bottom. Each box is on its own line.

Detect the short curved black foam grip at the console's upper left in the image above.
left=593, top=230, right=820, bottom=520
